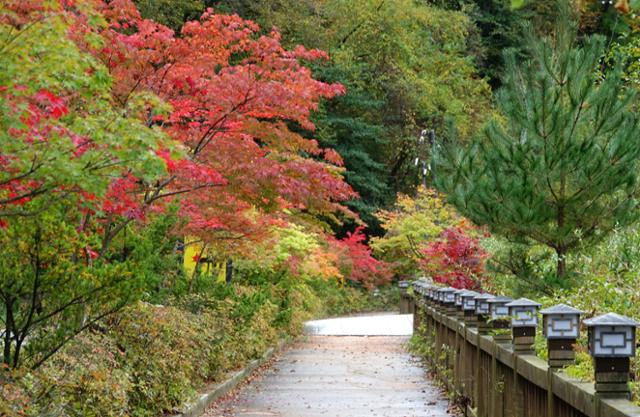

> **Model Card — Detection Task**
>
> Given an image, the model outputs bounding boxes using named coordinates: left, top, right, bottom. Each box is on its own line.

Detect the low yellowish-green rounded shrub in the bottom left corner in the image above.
left=0, top=330, right=131, bottom=417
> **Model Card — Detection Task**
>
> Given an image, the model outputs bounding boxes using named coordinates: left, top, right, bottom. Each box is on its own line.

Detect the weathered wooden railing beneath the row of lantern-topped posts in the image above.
left=401, top=286, right=640, bottom=417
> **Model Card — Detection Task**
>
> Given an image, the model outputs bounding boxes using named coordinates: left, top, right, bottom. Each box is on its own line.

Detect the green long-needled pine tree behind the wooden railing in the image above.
left=434, top=6, right=640, bottom=278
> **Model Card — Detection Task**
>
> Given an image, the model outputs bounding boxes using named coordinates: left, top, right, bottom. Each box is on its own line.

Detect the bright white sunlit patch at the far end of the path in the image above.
left=304, top=314, right=413, bottom=336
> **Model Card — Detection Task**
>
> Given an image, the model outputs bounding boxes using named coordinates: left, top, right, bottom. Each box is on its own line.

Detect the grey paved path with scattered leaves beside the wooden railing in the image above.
left=205, top=315, right=449, bottom=417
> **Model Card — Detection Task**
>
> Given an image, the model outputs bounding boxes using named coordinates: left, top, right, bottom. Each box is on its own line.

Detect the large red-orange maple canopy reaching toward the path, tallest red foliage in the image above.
left=94, top=0, right=355, bottom=250
